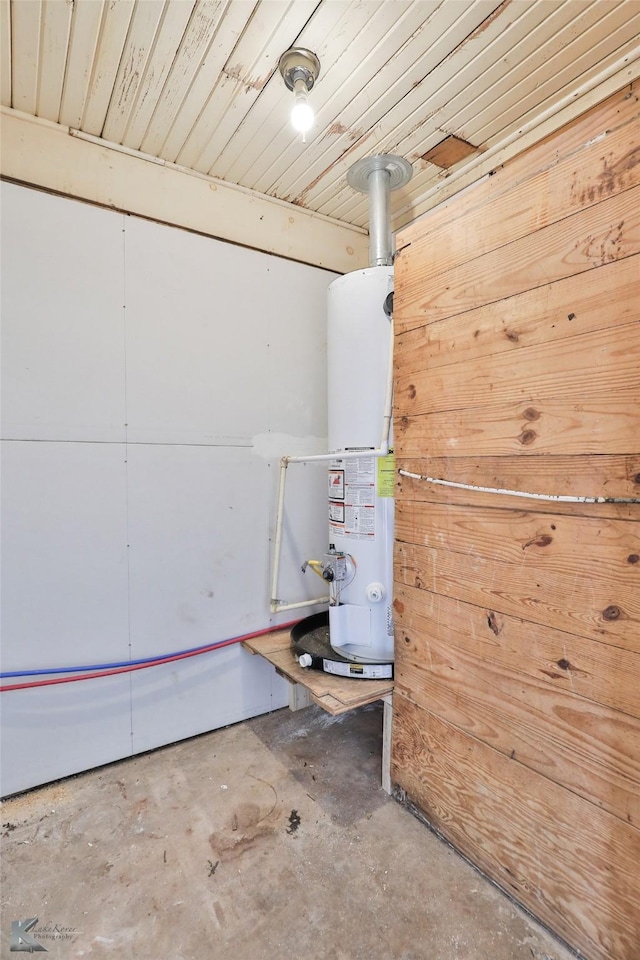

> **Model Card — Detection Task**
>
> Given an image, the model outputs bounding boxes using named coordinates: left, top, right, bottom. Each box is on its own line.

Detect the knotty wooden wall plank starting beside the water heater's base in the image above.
left=393, top=584, right=640, bottom=719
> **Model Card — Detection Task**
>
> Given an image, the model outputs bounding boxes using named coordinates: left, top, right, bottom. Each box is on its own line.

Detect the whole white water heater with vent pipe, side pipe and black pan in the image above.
left=282, top=154, right=412, bottom=679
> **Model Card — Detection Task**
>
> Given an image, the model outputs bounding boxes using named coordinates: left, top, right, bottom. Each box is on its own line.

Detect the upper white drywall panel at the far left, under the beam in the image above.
left=0, top=183, right=126, bottom=441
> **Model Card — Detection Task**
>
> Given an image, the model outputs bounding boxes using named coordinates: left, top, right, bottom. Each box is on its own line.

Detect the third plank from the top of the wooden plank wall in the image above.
left=394, top=187, right=640, bottom=333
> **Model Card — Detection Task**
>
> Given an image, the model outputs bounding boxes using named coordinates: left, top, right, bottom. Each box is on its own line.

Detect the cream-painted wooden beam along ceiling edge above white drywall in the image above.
left=0, top=107, right=368, bottom=273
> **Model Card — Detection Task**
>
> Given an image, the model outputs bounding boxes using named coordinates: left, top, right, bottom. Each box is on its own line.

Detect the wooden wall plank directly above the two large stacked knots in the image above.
left=395, top=318, right=640, bottom=416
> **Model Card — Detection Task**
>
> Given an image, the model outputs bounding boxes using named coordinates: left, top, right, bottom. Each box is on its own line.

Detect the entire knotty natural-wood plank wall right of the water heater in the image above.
left=392, top=85, right=640, bottom=960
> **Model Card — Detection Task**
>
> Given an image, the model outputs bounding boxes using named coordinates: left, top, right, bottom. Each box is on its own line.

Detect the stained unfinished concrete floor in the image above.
left=1, top=704, right=573, bottom=960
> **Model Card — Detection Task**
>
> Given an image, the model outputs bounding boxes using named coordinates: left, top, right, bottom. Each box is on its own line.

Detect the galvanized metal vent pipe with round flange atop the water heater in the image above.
left=347, top=153, right=413, bottom=267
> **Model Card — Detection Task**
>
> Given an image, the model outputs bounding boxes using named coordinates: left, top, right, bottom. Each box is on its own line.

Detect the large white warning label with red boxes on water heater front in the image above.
left=329, top=457, right=376, bottom=540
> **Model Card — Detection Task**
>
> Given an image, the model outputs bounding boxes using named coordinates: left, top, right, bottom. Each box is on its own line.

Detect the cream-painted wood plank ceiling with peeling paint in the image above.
left=0, top=0, right=640, bottom=226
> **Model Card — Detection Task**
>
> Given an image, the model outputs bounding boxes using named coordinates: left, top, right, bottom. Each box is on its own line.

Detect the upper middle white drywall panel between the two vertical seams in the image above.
left=126, top=217, right=270, bottom=446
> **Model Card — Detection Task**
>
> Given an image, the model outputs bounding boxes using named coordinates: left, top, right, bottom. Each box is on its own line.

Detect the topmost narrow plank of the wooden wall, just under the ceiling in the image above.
left=397, top=81, right=640, bottom=249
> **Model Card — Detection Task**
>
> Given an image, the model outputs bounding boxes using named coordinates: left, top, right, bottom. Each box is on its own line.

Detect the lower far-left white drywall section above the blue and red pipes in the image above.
left=2, top=440, right=128, bottom=668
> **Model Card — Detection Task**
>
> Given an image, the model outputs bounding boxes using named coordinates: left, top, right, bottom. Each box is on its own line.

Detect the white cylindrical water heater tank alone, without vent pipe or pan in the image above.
left=325, top=266, right=394, bottom=663
